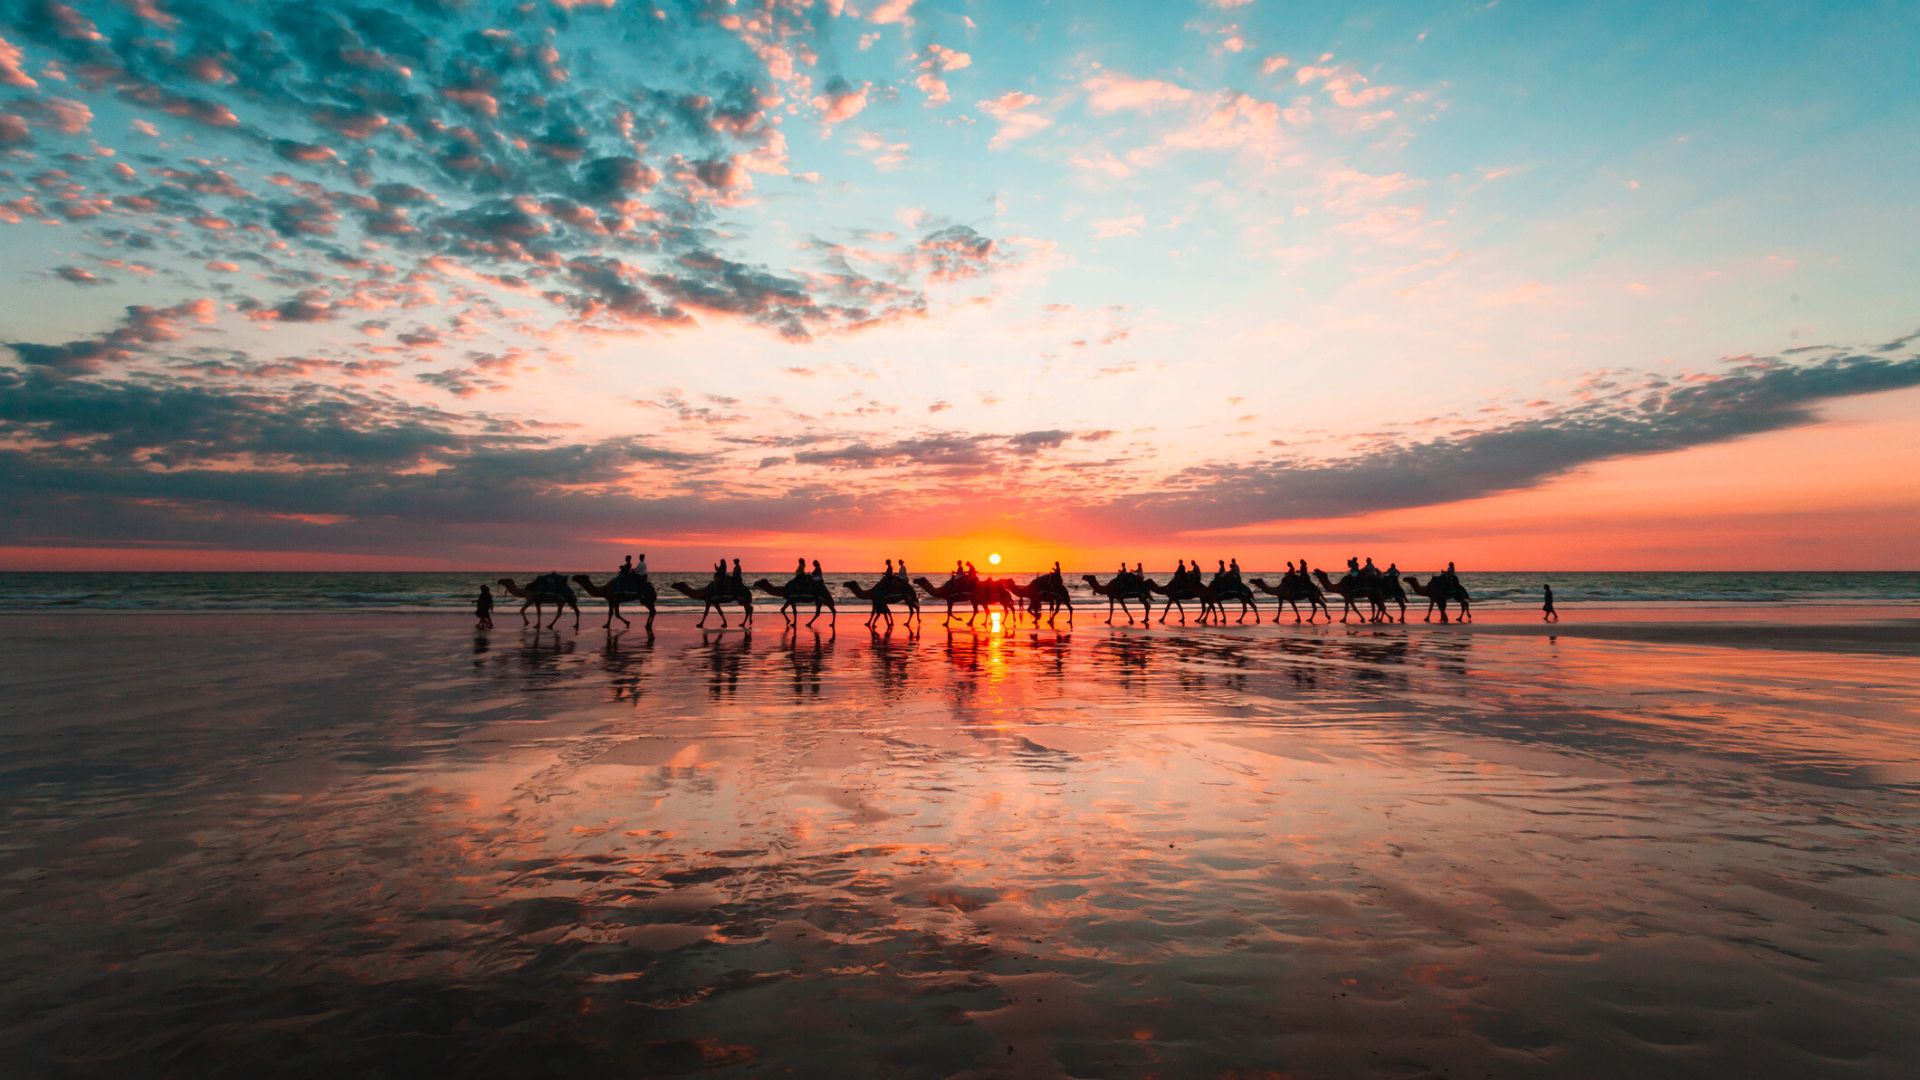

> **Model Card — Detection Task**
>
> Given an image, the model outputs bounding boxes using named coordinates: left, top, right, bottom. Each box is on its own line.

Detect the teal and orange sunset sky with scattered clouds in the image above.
left=0, top=0, right=1920, bottom=569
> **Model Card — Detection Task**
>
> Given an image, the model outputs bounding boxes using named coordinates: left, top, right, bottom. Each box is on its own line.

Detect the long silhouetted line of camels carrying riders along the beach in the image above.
left=482, top=555, right=1473, bottom=630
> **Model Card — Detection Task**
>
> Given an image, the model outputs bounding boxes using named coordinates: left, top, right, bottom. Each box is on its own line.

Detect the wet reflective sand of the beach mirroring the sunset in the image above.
left=0, top=607, right=1920, bottom=1076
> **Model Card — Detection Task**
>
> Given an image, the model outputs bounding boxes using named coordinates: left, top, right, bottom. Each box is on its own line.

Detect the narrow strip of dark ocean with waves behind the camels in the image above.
left=0, top=569, right=1920, bottom=611
